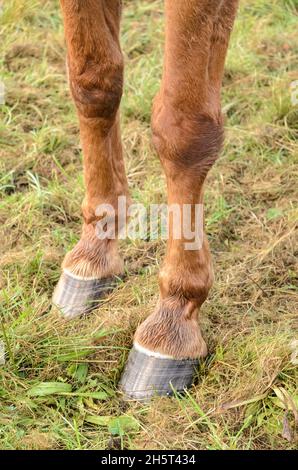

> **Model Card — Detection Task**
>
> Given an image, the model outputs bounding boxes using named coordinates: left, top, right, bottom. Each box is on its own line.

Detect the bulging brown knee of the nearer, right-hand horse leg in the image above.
left=152, top=99, right=223, bottom=178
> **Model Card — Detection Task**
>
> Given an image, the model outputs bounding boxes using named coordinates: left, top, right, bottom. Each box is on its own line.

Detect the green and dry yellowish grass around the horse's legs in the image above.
left=0, top=0, right=298, bottom=450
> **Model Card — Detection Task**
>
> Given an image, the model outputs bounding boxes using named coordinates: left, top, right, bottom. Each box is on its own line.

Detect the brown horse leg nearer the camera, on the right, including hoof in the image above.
left=121, top=0, right=235, bottom=400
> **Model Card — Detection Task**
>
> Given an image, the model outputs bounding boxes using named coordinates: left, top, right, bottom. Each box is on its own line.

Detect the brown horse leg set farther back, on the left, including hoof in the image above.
left=53, top=0, right=128, bottom=318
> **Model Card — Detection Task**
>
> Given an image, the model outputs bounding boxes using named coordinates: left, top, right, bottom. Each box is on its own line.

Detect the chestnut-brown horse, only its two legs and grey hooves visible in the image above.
left=53, top=0, right=238, bottom=401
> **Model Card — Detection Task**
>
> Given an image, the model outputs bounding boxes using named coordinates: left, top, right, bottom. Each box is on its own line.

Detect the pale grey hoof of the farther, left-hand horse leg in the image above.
left=52, top=271, right=115, bottom=320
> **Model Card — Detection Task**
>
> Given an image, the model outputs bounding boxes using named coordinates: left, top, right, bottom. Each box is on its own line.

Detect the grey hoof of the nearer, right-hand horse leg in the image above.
left=119, top=347, right=199, bottom=402
